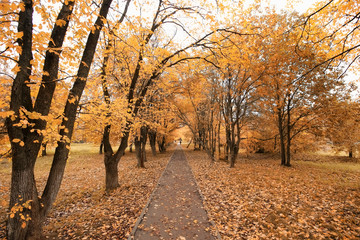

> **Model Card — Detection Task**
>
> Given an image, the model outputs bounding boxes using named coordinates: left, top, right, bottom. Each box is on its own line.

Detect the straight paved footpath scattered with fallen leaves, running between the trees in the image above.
left=129, top=147, right=217, bottom=240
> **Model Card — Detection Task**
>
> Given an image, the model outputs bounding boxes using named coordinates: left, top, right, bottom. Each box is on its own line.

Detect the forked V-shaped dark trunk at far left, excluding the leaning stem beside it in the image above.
left=6, top=0, right=74, bottom=240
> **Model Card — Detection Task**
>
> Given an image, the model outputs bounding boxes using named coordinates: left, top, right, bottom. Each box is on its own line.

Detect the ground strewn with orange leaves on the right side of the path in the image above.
left=186, top=151, right=360, bottom=239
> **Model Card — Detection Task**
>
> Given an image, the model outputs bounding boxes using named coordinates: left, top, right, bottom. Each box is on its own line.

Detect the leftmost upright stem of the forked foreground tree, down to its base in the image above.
left=6, top=0, right=36, bottom=237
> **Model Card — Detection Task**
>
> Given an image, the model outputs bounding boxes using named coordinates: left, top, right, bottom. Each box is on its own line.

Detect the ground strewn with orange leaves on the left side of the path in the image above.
left=0, top=145, right=173, bottom=239
